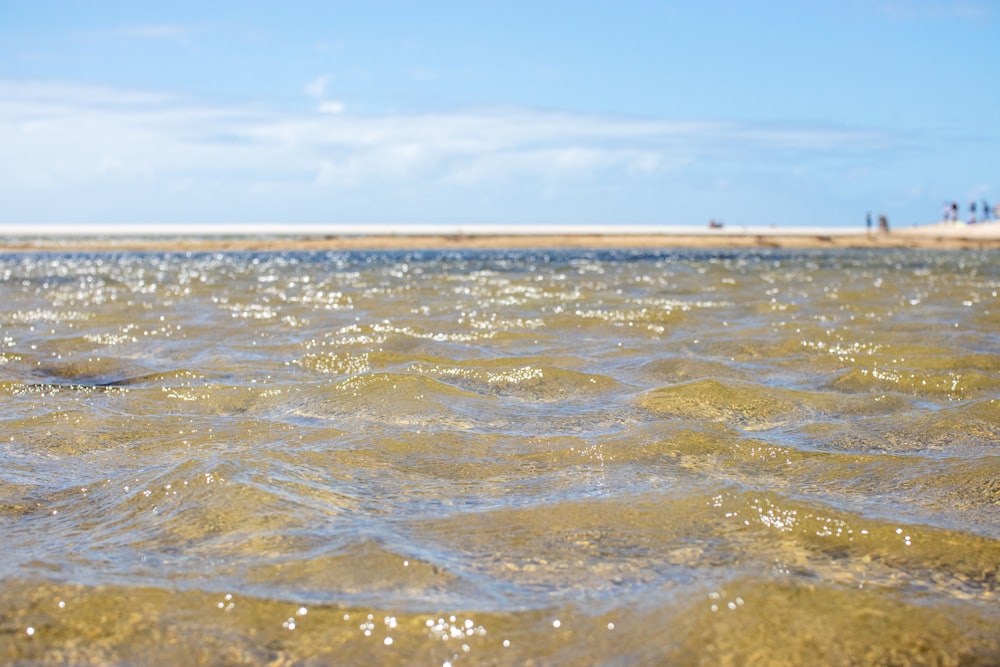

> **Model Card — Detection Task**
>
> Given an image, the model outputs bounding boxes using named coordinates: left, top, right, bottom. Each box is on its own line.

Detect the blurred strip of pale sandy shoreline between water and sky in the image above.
left=0, top=221, right=1000, bottom=252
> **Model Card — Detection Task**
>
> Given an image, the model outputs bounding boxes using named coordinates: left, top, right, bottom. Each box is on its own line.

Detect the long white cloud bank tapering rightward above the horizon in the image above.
left=0, top=77, right=900, bottom=217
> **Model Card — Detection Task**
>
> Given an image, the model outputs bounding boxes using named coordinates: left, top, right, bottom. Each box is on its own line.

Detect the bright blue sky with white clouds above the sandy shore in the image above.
left=0, top=0, right=1000, bottom=227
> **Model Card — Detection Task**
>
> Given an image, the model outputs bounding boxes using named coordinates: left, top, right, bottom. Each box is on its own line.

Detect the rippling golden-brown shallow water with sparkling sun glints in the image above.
left=0, top=250, right=1000, bottom=667
